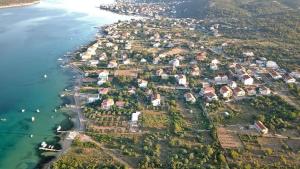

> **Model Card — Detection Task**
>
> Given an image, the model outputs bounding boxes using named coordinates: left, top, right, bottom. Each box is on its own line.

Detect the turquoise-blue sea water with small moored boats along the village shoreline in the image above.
left=0, top=0, right=130, bottom=169
